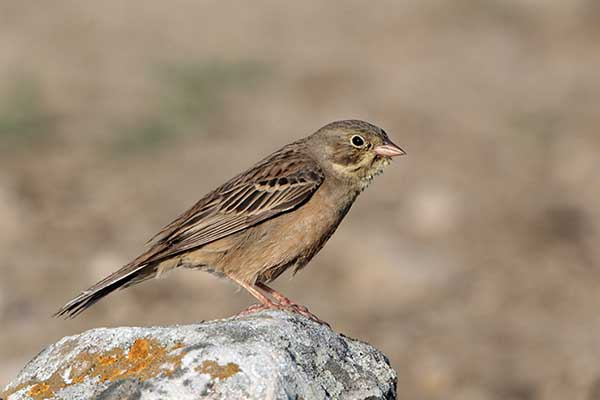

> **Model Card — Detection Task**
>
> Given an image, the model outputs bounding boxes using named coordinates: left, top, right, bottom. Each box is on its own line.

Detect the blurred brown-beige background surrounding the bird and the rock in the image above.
left=0, top=0, right=600, bottom=400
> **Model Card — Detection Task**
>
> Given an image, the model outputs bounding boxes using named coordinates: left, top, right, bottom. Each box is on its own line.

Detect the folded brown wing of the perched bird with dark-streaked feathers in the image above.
left=141, top=148, right=324, bottom=263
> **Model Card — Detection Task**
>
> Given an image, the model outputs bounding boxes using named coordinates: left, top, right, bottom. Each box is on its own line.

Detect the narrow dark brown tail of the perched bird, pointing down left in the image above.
left=53, top=262, right=158, bottom=318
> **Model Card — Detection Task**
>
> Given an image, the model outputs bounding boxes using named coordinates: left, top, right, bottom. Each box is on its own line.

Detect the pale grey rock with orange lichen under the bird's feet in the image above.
left=0, top=311, right=396, bottom=400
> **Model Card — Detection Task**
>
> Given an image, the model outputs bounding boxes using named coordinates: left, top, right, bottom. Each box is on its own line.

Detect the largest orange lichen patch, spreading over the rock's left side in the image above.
left=0, top=338, right=185, bottom=400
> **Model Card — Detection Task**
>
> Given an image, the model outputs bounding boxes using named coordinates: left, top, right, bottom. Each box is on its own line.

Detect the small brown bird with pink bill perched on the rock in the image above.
left=55, top=120, right=405, bottom=322
